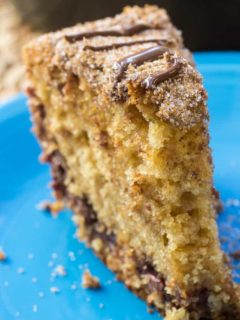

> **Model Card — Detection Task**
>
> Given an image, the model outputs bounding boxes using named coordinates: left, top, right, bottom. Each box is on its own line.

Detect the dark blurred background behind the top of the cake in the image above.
left=13, top=0, right=240, bottom=50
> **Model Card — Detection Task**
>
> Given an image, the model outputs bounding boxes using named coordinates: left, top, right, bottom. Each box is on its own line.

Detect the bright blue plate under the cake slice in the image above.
left=0, top=53, right=240, bottom=320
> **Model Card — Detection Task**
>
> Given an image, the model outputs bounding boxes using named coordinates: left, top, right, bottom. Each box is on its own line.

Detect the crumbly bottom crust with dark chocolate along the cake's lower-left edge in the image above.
left=42, top=151, right=238, bottom=320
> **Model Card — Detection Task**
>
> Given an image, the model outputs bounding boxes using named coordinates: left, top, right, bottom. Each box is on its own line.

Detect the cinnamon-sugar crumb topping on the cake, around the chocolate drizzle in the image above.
left=24, top=5, right=208, bottom=128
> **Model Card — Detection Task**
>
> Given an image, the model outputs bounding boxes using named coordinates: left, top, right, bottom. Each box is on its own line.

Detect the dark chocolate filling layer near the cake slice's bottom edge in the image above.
left=42, top=151, right=218, bottom=319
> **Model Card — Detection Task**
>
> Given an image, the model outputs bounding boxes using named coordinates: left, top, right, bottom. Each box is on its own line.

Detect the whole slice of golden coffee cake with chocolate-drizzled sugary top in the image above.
left=23, top=5, right=240, bottom=320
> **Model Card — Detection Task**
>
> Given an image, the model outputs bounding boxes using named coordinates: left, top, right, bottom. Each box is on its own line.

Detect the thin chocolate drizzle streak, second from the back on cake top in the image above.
left=83, top=39, right=170, bottom=51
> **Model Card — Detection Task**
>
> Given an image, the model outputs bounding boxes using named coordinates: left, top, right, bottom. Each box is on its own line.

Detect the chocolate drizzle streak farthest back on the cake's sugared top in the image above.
left=65, top=24, right=156, bottom=43
